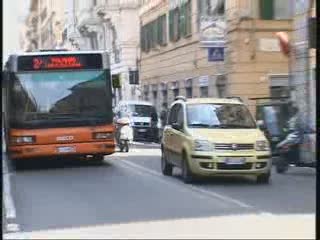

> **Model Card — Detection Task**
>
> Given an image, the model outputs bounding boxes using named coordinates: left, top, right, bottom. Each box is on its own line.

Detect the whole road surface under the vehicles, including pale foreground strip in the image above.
left=3, top=145, right=316, bottom=239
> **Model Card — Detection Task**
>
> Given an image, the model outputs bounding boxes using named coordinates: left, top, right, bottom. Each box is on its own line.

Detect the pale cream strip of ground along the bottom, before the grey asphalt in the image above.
left=13, top=213, right=316, bottom=239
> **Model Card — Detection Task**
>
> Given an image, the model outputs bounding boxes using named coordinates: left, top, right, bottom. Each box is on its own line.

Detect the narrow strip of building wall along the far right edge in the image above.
left=290, top=0, right=317, bottom=161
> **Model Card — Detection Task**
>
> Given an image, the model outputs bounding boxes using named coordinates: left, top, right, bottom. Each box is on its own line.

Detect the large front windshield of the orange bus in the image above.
left=10, top=70, right=112, bottom=127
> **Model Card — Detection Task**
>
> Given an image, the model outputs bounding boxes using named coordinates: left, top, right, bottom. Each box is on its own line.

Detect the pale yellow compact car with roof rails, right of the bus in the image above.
left=161, top=97, right=272, bottom=183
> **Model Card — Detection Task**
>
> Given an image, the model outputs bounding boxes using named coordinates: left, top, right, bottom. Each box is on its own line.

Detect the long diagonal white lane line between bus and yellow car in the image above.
left=111, top=160, right=255, bottom=209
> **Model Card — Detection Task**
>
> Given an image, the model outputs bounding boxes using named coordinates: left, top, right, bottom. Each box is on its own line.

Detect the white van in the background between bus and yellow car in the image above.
left=115, top=101, right=160, bottom=142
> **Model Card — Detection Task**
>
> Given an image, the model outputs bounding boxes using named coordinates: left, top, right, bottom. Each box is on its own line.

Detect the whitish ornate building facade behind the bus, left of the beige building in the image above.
left=67, top=0, right=141, bottom=101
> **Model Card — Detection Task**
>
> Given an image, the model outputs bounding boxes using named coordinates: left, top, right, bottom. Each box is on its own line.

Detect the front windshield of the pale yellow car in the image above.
left=187, top=104, right=256, bottom=129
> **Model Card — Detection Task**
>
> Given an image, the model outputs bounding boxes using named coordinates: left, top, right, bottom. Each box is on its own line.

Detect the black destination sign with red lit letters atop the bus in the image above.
left=18, top=54, right=102, bottom=71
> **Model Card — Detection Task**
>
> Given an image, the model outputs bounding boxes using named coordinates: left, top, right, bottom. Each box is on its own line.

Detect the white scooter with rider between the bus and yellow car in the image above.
left=116, top=118, right=133, bottom=152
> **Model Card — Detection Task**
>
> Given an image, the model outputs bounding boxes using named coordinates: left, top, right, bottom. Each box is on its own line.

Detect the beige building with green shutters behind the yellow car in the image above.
left=140, top=0, right=292, bottom=112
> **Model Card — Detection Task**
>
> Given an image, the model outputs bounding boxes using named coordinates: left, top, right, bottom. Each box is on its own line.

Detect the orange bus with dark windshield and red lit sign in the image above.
left=3, top=50, right=115, bottom=162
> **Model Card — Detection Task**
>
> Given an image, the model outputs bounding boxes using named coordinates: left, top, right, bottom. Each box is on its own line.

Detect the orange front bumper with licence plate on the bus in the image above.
left=9, top=141, right=115, bottom=159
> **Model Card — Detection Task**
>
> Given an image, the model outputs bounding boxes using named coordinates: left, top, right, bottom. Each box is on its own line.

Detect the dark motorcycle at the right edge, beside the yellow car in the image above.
left=275, top=128, right=316, bottom=173
